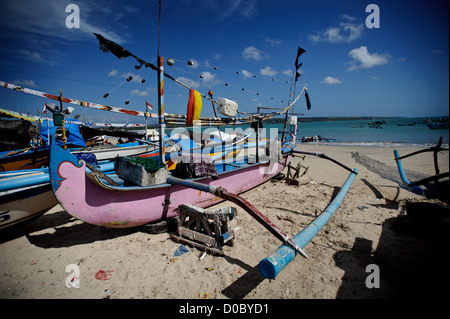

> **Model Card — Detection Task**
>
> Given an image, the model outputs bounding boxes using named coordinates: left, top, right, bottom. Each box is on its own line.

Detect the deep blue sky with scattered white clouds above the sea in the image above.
left=0, top=0, right=449, bottom=122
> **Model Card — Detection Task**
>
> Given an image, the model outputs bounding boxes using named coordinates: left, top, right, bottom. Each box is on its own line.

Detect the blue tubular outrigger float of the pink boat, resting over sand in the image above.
left=259, top=169, right=358, bottom=279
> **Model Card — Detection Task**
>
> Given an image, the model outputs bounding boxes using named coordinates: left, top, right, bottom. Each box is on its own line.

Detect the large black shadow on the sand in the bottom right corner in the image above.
left=333, top=202, right=450, bottom=299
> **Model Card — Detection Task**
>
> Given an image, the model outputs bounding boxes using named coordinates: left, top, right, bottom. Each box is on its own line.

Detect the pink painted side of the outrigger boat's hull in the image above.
left=52, top=157, right=288, bottom=228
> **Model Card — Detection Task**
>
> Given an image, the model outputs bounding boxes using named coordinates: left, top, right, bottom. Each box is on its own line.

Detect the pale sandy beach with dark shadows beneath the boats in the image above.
left=0, top=145, right=449, bottom=299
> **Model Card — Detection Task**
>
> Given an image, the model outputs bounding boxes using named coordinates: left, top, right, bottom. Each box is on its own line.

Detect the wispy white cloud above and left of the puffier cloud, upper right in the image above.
left=308, top=14, right=364, bottom=43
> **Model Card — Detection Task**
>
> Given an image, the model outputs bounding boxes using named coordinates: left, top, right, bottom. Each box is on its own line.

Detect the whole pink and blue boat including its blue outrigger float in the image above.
left=0, top=1, right=357, bottom=278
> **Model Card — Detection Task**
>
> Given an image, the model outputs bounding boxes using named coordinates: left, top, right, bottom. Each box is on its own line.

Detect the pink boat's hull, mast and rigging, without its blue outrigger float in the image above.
left=46, top=27, right=309, bottom=227
